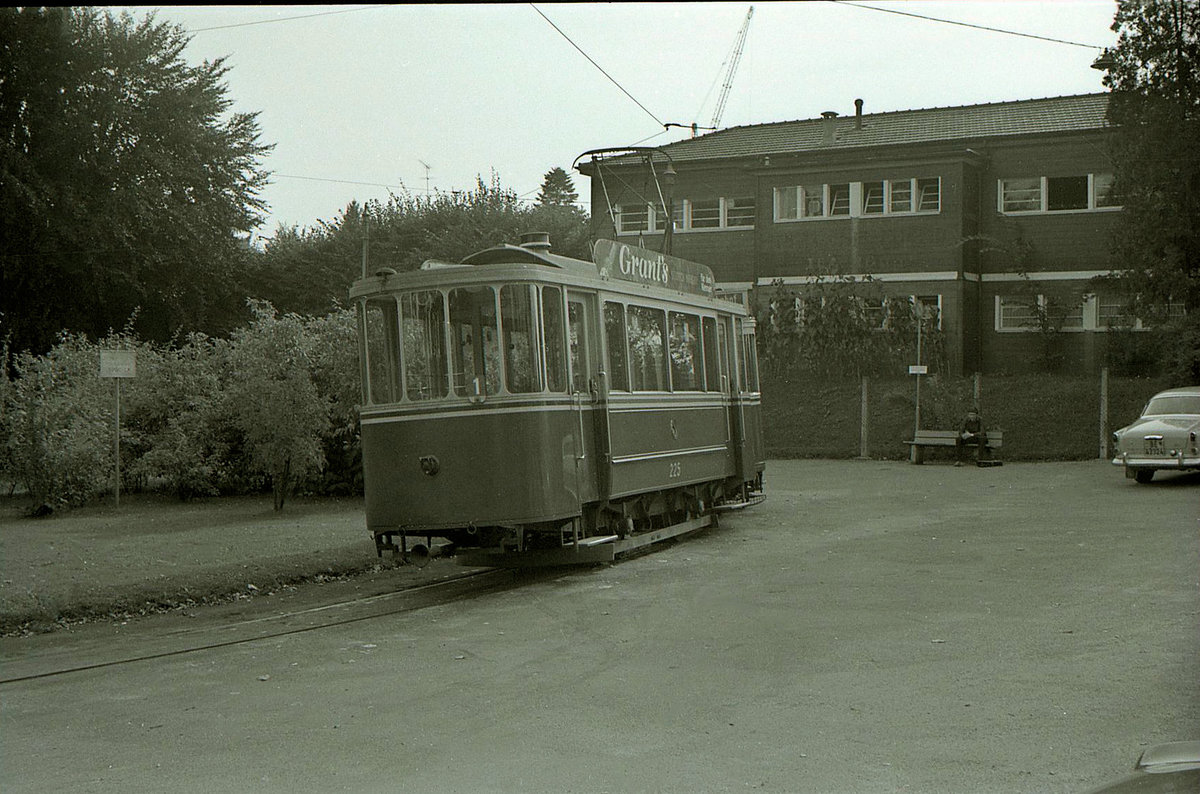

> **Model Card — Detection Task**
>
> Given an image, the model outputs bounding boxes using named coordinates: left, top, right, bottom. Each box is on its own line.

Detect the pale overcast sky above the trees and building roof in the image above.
left=122, top=0, right=1116, bottom=239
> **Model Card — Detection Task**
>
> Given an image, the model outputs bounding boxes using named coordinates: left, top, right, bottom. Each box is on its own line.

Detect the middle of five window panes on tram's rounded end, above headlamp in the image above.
left=450, top=287, right=500, bottom=397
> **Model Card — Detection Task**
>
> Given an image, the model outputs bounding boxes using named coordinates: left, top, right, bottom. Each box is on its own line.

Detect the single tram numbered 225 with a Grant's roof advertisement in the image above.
left=350, top=234, right=764, bottom=566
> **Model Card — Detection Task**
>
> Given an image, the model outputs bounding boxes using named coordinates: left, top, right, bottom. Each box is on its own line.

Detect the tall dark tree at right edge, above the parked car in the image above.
left=1104, top=0, right=1200, bottom=383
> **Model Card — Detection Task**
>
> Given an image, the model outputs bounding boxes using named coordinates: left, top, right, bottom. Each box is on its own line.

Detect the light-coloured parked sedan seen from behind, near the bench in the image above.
left=1112, top=386, right=1200, bottom=482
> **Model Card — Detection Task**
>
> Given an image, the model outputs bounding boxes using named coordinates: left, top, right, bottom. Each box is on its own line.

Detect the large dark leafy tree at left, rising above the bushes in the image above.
left=0, top=7, right=270, bottom=351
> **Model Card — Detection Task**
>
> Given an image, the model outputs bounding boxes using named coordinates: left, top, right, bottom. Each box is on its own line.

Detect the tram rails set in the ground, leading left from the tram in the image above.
left=0, top=569, right=523, bottom=686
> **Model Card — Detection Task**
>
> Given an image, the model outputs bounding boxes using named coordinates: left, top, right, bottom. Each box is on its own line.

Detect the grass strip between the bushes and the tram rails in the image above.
left=0, top=494, right=379, bottom=634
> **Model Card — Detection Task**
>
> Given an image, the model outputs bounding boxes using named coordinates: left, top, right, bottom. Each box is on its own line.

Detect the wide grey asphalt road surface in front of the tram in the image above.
left=0, top=462, right=1200, bottom=794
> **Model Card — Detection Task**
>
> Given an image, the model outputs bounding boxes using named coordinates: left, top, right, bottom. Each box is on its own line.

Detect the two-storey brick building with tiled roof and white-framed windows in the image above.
left=580, top=94, right=1135, bottom=373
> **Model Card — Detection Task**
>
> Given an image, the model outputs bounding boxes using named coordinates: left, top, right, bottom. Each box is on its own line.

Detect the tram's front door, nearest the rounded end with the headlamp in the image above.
left=566, top=291, right=605, bottom=501
